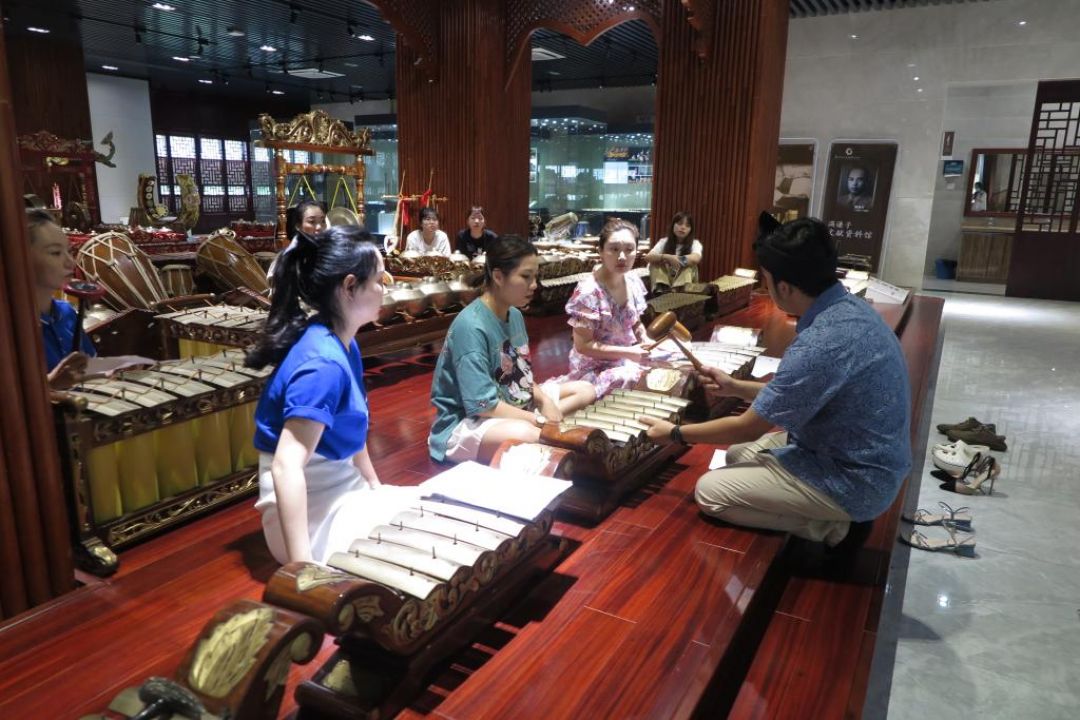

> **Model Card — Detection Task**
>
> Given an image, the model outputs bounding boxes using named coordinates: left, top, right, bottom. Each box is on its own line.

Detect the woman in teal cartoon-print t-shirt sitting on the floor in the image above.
left=428, top=235, right=595, bottom=462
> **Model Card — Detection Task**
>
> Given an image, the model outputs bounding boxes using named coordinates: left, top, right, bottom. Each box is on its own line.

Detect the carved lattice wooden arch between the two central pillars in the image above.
left=505, top=0, right=662, bottom=86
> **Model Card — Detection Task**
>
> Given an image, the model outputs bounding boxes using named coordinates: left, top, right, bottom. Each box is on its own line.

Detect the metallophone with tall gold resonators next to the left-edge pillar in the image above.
left=55, top=350, right=272, bottom=573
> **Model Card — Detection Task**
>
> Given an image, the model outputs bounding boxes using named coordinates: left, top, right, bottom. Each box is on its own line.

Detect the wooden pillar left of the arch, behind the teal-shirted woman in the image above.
left=396, top=0, right=532, bottom=237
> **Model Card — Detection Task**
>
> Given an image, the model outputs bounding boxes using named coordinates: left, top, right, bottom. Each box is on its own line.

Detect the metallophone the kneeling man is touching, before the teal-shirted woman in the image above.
left=491, top=382, right=697, bottom=522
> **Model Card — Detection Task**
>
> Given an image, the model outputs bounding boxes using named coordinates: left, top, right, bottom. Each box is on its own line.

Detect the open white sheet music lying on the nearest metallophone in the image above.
left=419, top=460, right=572, bottom=521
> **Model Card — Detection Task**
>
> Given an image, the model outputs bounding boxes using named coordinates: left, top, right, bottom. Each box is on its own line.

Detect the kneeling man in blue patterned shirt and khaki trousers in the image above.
left=643, top=214, right=912, bottom=549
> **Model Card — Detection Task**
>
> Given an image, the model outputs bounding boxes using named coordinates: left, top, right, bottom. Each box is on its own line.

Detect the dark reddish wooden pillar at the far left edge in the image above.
left=0, top=35, right=77, bottom=619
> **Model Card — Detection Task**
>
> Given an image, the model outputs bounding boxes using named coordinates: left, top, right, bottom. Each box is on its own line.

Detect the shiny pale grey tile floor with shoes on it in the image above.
left=864, top=294, right=1080, bottom=720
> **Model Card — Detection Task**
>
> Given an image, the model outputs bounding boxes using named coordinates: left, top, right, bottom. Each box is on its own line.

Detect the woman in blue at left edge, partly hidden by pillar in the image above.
left=26, top=208, right=97, bottom=390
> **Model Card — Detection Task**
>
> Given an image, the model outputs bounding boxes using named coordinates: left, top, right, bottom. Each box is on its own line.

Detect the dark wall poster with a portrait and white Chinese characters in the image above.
left=822, top=141, right=897, bottom=272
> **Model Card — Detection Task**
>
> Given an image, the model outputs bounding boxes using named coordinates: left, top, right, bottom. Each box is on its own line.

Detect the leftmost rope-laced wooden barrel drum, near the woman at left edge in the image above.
left=76, top=232, right=167, bottom=310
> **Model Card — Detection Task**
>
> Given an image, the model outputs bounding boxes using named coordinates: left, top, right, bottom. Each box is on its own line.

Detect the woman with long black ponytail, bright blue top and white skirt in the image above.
left=246, top=226, right=386, bottom=562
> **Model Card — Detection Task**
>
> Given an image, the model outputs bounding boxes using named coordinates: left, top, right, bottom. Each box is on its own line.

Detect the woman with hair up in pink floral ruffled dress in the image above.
left=553, top=218, right=649, bottom=403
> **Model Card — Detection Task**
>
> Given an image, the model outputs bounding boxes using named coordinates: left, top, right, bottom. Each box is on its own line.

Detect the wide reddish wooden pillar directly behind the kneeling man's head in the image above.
left=652, top=0, right=788, bottom=280
